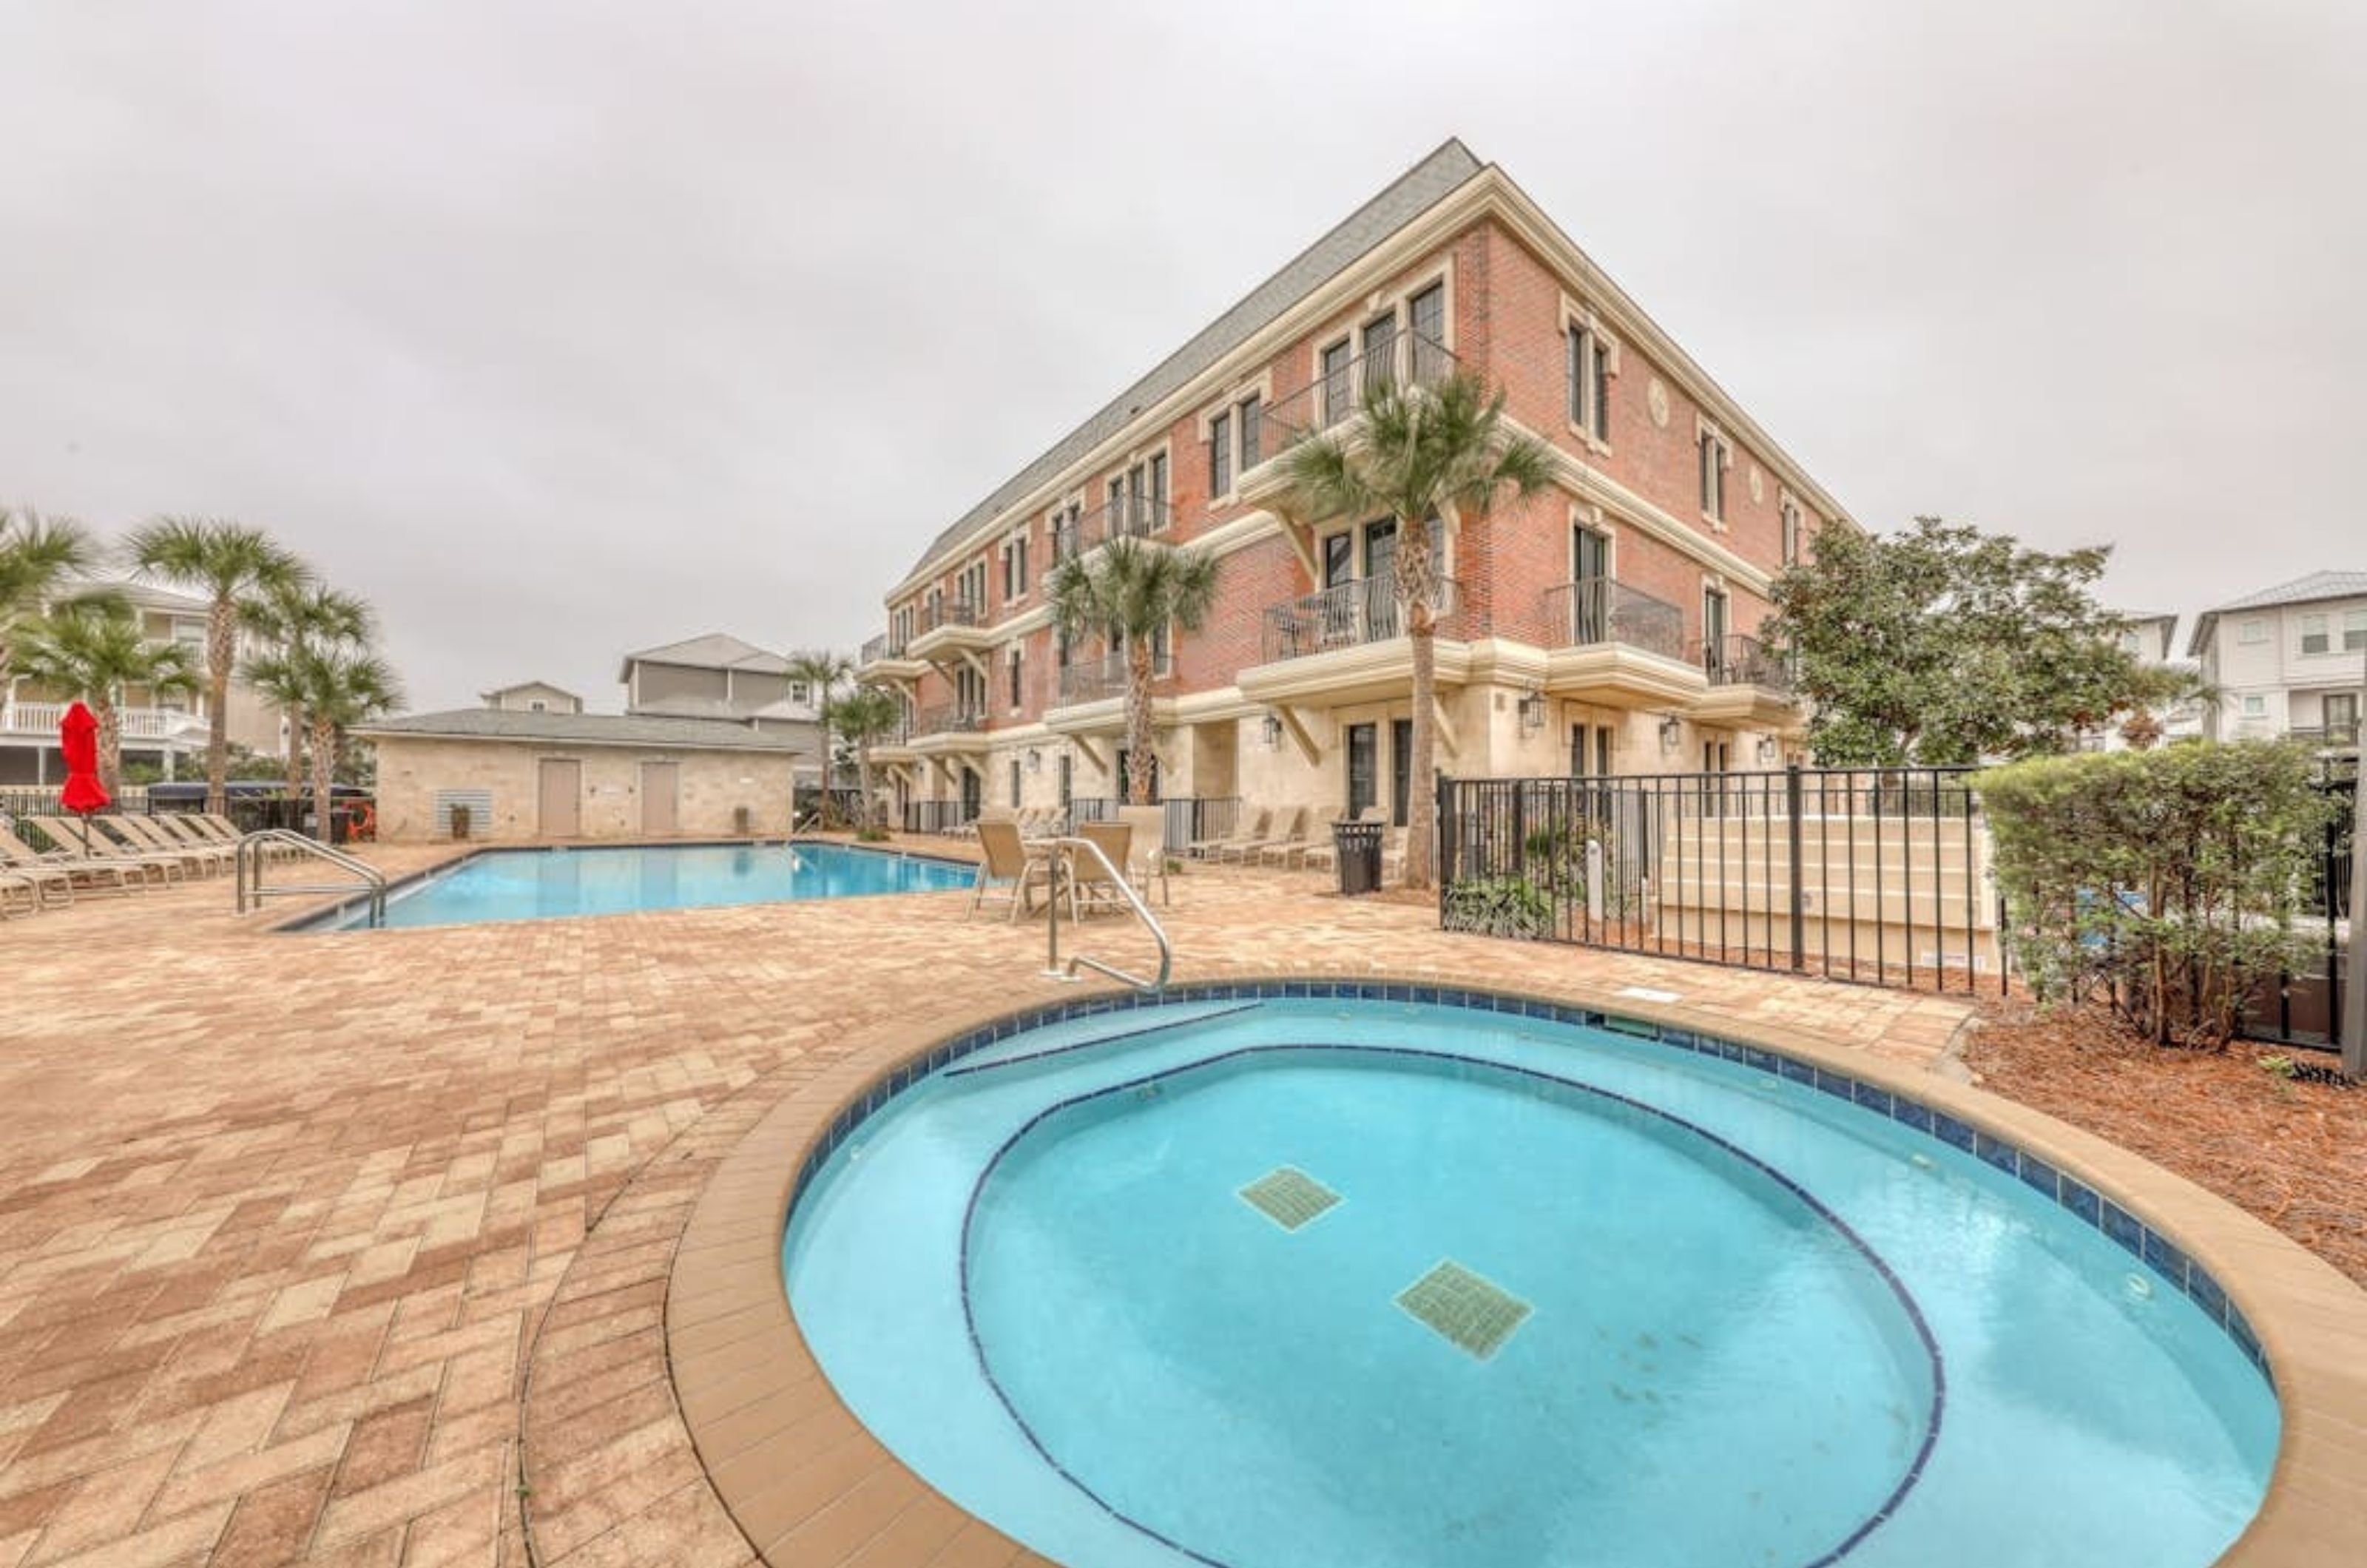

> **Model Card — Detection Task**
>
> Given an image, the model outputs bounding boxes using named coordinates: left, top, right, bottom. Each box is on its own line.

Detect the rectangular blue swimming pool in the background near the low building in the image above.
left=296, top=843, right=975, bottom=931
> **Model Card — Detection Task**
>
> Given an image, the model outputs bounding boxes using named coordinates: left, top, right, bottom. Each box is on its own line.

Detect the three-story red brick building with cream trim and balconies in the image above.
left=862, top=142, right=1854, bottom=822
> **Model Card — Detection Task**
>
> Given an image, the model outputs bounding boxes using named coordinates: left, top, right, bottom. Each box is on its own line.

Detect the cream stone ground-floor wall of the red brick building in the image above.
left=878, top=682, right=1799, bottom=822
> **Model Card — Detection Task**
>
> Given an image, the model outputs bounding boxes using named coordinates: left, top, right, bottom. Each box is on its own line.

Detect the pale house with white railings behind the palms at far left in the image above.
left=0, top=583, right=286, bottom=784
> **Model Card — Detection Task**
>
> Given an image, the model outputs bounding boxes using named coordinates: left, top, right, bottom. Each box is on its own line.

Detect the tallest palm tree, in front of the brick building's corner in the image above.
left=1283, top=374, right=1553, bottom=888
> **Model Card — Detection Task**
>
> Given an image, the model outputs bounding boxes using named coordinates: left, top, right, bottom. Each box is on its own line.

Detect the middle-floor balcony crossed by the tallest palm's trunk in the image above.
left=1238, top=578, right=1470, bottom=701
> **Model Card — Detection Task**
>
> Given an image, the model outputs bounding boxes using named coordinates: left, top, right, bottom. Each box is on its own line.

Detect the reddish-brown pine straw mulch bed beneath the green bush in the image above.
left=1965, top=997, right=2367, bottom=1286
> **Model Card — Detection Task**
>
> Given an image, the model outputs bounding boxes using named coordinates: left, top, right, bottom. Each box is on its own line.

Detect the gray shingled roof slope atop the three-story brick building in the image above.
left=904, top=138, right=1482, bottom=578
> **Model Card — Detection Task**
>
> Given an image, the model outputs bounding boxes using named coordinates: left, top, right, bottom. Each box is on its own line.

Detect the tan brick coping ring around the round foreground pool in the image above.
left=663, top=967, right=2367, bottom=1568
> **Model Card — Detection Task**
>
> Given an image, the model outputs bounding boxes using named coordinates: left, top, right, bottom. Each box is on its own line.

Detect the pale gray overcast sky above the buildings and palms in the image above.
left=0, top=0, right=2367, bottom=709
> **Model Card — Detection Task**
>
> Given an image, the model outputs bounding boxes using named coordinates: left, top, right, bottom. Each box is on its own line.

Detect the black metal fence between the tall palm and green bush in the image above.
left=1439, top=768, right=2005, bottom=990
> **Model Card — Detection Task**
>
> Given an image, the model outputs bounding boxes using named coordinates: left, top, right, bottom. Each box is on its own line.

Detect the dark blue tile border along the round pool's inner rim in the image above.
left=791, top=981, right=2277, bottom=1388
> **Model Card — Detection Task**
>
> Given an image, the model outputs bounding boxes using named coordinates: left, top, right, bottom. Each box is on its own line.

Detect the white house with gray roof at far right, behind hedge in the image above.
left=2187, top=571, right=2367, bottom=746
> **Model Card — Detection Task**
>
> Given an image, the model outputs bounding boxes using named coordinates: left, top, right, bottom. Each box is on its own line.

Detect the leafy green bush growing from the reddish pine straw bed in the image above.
left=1974, top=741, right=2334, bottom=1044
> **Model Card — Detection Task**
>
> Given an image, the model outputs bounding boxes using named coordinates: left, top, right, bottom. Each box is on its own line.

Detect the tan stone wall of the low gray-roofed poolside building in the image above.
left=374, top=734, right=791, bottom=843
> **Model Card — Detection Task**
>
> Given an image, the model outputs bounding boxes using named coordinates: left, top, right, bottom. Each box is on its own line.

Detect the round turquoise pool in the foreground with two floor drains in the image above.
left=783, top=985, right=2280, bottom=1568
